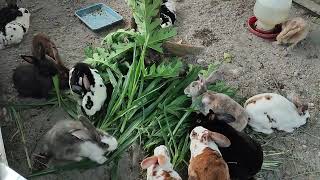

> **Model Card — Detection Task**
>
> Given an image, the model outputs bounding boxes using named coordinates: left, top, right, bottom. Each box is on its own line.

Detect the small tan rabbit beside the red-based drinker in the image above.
left=277, top=17, right=309, bottom=48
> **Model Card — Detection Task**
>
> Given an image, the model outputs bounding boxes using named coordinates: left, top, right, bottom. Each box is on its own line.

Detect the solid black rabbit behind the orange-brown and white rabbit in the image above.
left=191, top=110, right=263, bottom=180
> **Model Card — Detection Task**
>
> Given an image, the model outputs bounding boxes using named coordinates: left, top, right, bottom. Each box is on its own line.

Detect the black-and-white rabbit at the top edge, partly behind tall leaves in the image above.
left=160, top=0, right=176, bottom=28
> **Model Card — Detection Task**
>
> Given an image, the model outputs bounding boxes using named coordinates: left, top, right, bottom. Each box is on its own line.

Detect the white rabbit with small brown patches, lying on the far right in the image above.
left=244, top=93, right=310, bottom=134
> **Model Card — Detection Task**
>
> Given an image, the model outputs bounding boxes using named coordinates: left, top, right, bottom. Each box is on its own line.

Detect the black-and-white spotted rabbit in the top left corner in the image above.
left=0, top=7, right=30, bottom=49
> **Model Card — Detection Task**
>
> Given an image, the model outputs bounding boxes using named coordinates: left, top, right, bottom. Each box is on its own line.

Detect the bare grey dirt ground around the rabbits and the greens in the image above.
left=0, top=0, right=320, bottom=180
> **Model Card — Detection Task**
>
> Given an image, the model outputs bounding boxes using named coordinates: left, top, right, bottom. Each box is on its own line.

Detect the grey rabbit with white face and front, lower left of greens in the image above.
left=42, top=116, right=118, bottom=164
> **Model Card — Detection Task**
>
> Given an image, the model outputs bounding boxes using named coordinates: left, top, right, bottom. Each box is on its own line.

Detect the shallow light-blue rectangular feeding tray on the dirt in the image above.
left=75, top=3, right=123, bottom=31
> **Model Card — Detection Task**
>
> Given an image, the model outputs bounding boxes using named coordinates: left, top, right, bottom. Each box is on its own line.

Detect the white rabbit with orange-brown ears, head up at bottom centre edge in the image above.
left=141, top=145, right=182, bottom=180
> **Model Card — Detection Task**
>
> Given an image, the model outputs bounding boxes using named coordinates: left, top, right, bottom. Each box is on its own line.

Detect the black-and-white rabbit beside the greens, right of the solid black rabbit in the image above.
left=69, top=63, right=107, bottom=116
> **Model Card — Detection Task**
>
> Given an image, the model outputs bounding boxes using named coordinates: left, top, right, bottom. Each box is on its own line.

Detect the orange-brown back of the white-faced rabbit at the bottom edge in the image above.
left=189, top=147, right=230, bottom=180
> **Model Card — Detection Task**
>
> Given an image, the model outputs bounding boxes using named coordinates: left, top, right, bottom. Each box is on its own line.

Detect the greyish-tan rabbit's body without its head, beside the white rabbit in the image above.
left=200, top=92, right=249, bottom=131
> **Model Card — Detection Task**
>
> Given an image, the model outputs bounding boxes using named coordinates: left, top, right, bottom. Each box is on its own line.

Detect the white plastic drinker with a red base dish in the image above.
left=247, top=0, right=292, bottom=39
